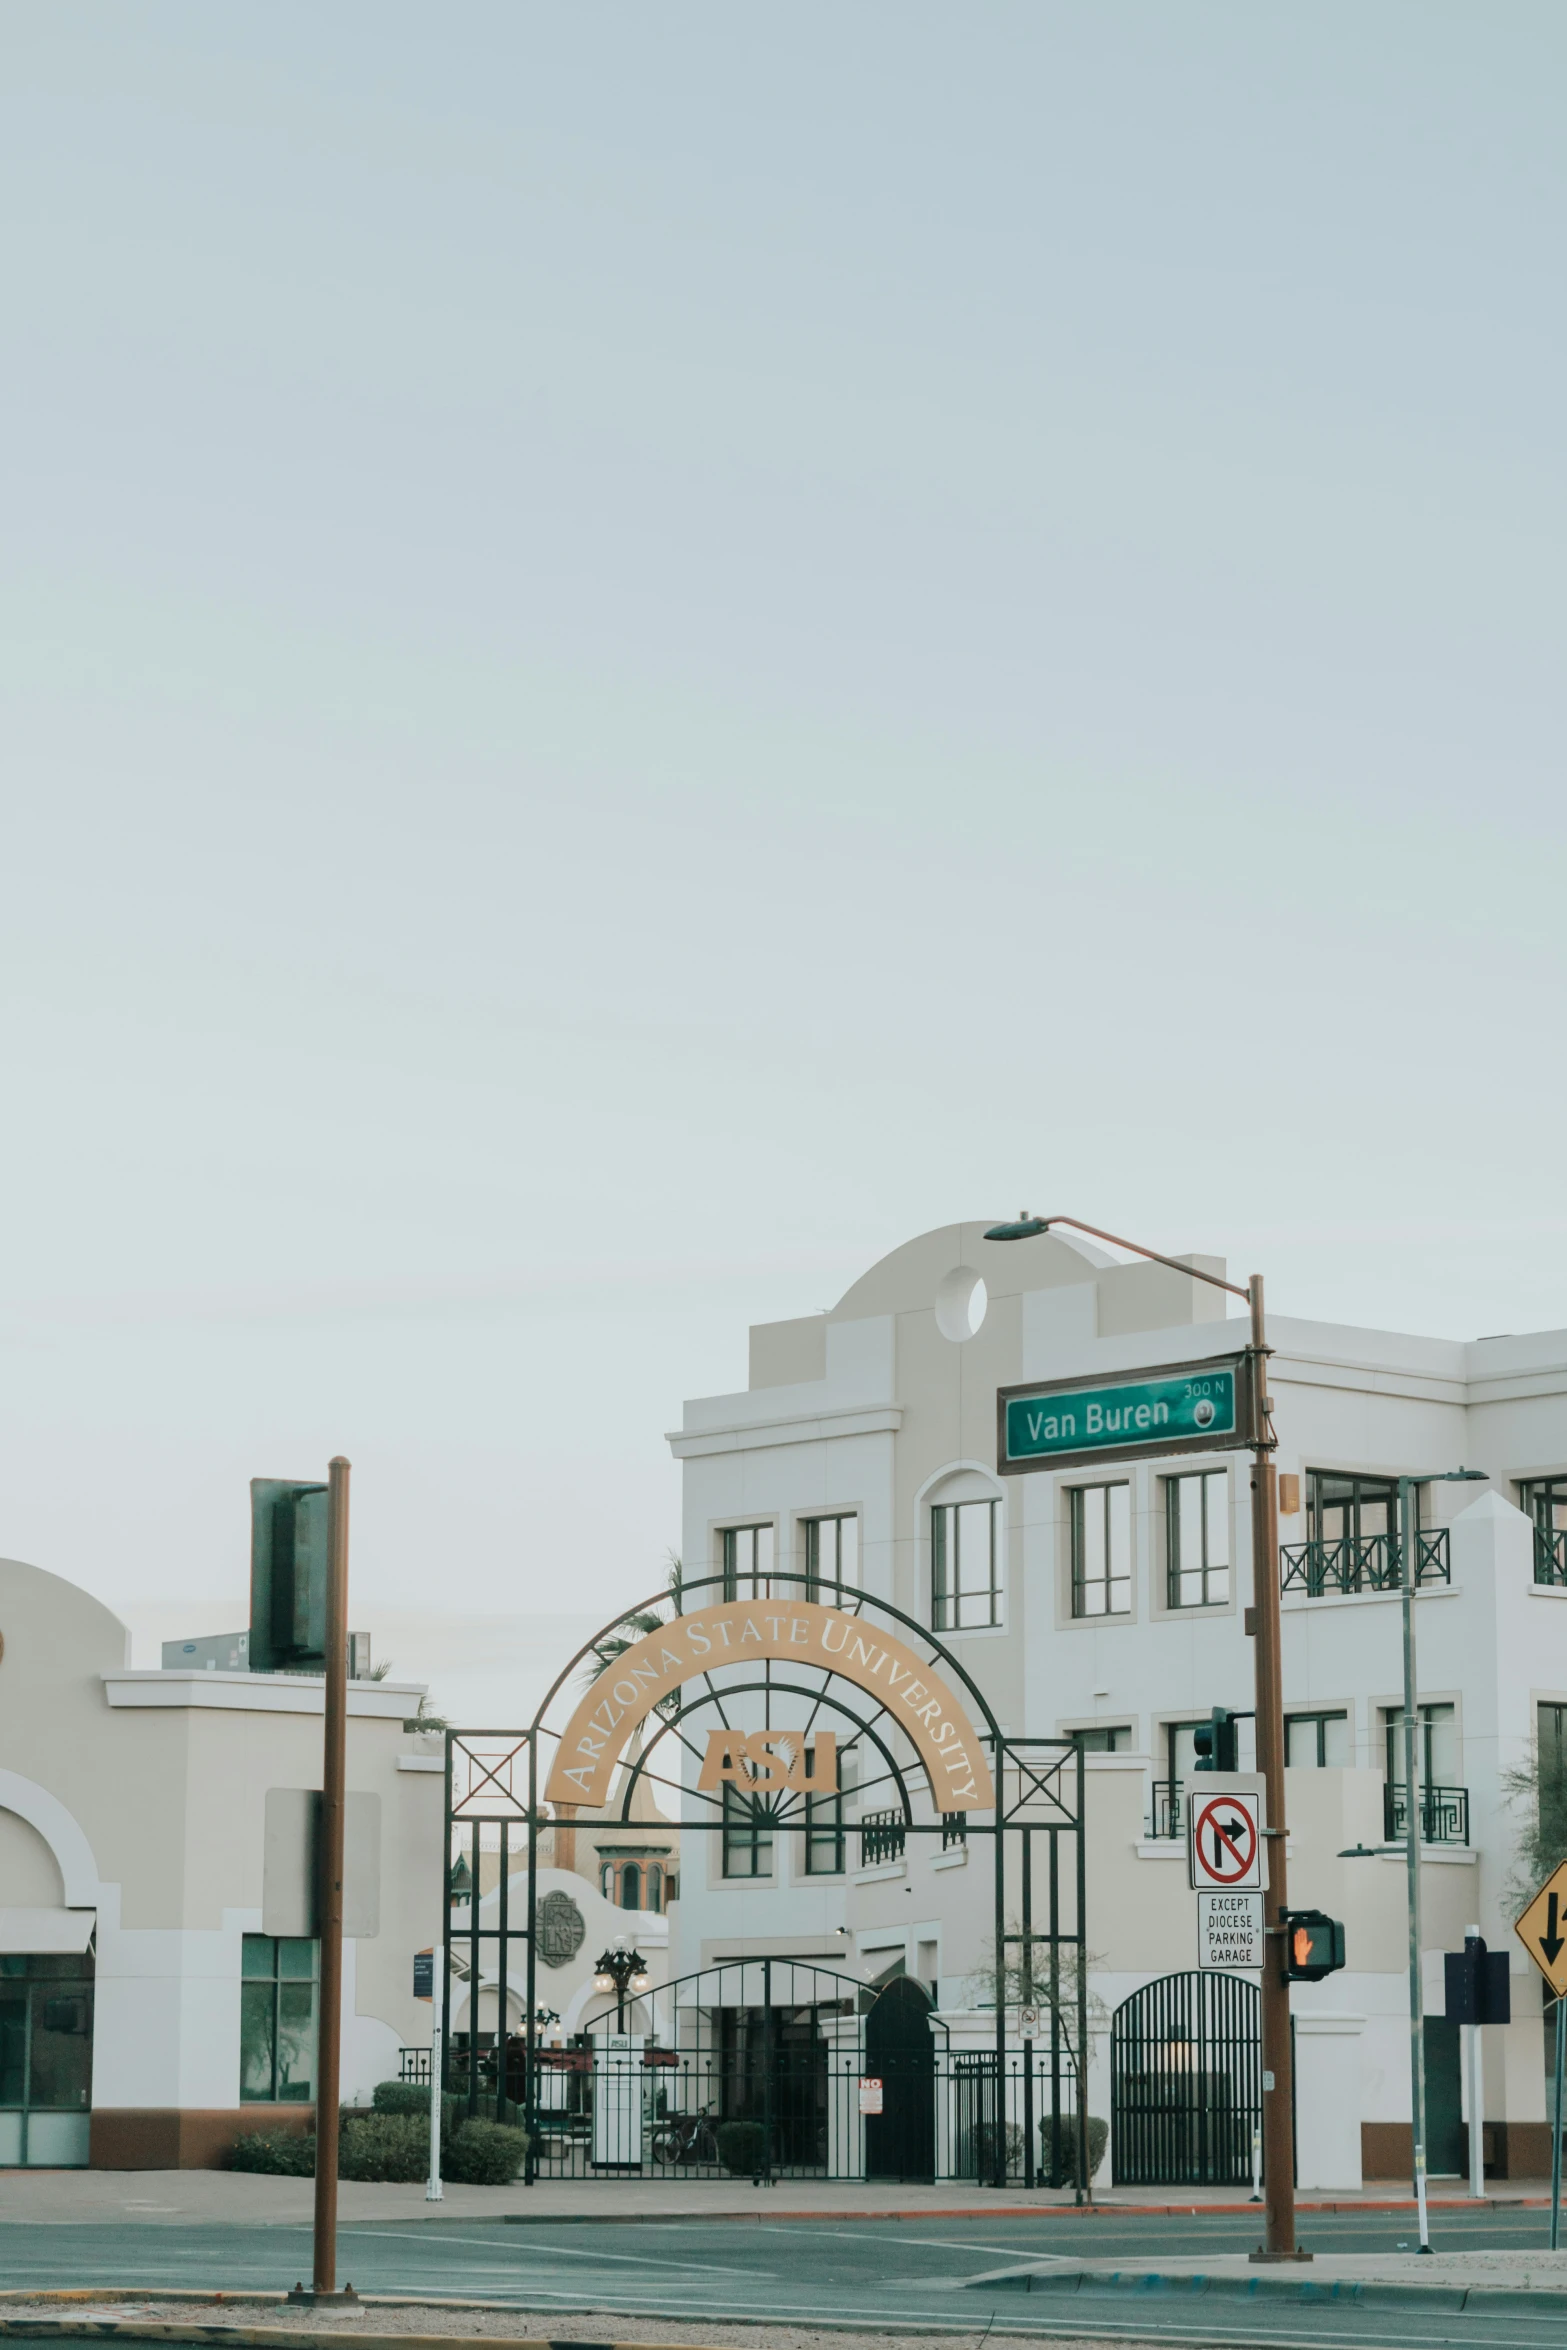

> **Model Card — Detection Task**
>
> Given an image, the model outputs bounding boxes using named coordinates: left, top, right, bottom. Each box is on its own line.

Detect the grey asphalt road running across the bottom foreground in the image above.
left=0, top=2209, right=1567, bottom=2350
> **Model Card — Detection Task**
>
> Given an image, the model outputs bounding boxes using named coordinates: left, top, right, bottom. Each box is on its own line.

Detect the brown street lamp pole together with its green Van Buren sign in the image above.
left=984, top=1213, right=1311, bottom=2261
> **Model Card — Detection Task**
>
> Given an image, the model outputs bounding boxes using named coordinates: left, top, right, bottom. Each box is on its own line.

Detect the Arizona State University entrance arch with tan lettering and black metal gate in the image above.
left=442, top=1572, right=1088, bottom=2193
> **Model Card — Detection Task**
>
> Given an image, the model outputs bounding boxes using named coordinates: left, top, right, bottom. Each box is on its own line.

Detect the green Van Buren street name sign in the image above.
left=996, top=1354, right=1255, bottom=1476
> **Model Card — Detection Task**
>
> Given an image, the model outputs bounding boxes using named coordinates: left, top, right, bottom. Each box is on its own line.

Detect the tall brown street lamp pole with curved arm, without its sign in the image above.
left=984, top=1215, right=1311, bottom=2261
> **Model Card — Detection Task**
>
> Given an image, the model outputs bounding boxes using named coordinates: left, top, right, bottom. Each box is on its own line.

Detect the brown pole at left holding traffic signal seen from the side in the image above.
left=312, top=1452, right=348, bottom=2298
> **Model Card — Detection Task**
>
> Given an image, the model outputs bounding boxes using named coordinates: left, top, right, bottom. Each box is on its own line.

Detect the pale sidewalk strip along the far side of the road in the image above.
left=0, top=2171, right=1551, bottom=2228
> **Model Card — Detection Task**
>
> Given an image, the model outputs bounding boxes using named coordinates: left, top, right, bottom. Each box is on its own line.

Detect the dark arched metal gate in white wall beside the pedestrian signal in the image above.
left=1109, top=1972, right=1262, bottom=2188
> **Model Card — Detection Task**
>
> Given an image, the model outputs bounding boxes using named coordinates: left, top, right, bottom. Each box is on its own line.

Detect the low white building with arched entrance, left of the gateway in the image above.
left=0, top=1560, right=444, bottom=2169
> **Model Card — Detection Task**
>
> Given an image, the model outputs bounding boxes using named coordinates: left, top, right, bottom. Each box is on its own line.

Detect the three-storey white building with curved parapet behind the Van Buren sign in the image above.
left=670, top=1224, right=1567, bottom=2186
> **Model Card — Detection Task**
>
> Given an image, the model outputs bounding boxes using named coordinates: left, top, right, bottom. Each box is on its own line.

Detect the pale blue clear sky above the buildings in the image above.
left=0, top=0, right=1567, bottom=1671
